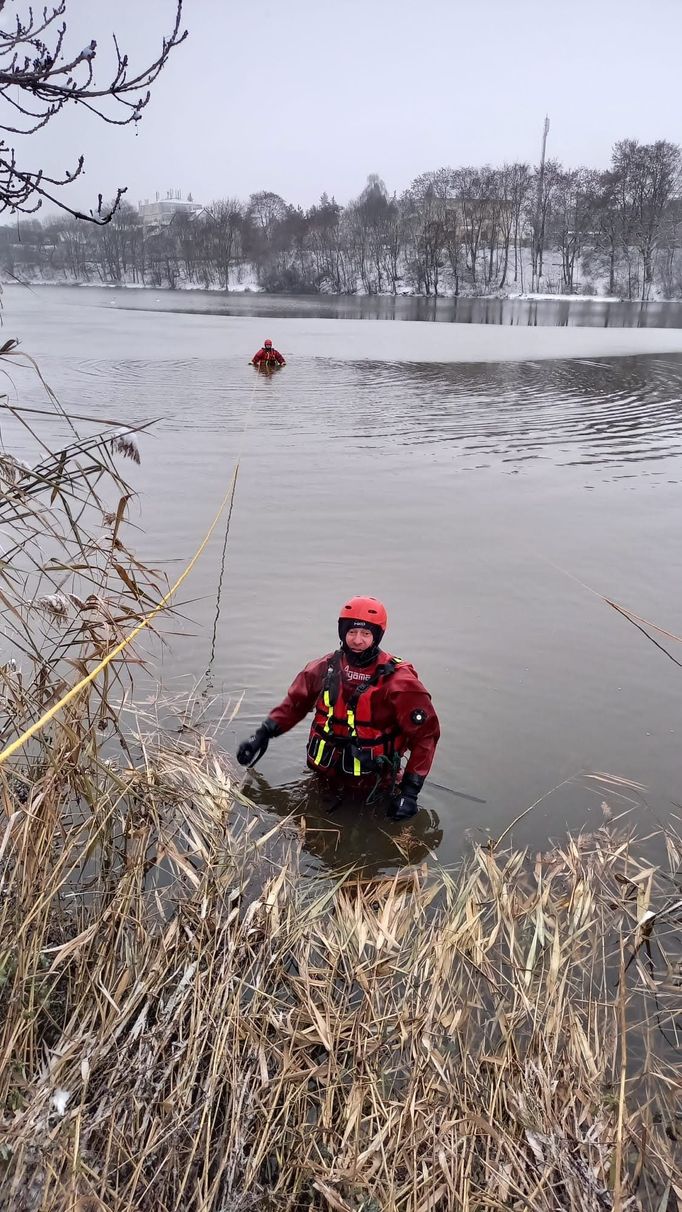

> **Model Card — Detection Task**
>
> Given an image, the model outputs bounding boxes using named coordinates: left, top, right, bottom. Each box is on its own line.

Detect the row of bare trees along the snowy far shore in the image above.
left=0, top=135, right=682, bottom=298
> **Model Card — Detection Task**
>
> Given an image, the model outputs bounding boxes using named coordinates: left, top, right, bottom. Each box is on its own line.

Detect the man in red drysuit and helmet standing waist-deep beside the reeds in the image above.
left=237, top=598, right=440, bottom=821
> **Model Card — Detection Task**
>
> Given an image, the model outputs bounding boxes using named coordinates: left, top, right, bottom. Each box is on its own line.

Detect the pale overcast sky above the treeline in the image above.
left=18, top=0, right=682, bottom=215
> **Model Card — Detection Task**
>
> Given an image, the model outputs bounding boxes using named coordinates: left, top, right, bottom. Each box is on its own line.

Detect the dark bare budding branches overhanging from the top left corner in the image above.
left=0, top=0, right=187, bottom=223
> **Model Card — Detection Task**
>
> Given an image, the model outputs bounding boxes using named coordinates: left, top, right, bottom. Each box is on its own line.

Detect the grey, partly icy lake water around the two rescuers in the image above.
left=2, top=287, right=682, bottom=867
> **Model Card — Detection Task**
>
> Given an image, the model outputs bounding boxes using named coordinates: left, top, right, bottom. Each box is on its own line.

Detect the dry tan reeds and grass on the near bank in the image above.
left=0, top=363, right=682, bottom=1212
